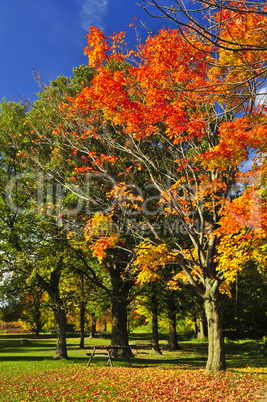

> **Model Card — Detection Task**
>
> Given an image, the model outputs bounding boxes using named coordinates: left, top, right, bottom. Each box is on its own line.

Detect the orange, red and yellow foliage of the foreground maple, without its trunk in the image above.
left=59, top=17, right=267, bottom=291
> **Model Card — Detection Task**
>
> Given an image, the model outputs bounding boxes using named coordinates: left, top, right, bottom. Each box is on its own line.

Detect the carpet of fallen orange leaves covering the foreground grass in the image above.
left=0, top=366, right=262, bottom=402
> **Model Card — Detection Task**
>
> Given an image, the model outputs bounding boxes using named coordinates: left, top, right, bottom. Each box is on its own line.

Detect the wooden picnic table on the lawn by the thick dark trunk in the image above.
left=86, top=345, right=134, bottom=367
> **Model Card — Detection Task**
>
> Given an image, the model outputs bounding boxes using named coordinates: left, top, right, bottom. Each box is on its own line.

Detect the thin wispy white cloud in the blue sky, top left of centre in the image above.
left=80, top=0, right=109, bottom=32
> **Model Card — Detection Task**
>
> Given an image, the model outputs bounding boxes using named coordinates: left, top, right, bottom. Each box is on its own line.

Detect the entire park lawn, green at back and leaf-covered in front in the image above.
left=0, top=334, right=267, bottom=402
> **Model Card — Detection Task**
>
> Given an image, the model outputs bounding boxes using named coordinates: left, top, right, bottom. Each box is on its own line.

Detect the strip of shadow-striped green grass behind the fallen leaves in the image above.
left=0, top=334, right=267, bottom=369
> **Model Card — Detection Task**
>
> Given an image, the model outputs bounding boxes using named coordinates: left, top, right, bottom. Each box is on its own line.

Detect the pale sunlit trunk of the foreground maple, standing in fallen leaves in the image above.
left=204, top=278, right=226, bottom=372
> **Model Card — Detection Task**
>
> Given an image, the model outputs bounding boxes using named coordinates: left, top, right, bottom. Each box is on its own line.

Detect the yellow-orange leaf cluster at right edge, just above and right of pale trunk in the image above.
left=214, top=185, right=267, bottom=290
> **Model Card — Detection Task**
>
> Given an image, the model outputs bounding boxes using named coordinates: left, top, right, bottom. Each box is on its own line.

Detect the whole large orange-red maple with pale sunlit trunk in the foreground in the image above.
left=49, top=19, right=265, bottom=371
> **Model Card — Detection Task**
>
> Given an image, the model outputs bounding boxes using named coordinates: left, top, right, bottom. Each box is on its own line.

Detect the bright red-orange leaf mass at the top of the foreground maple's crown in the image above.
left=78, top=27, right=214, bottom=144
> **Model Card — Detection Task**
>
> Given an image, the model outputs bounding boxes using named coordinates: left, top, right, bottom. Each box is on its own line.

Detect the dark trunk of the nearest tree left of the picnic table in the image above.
left=53, top=305, right=68, bottom=359
